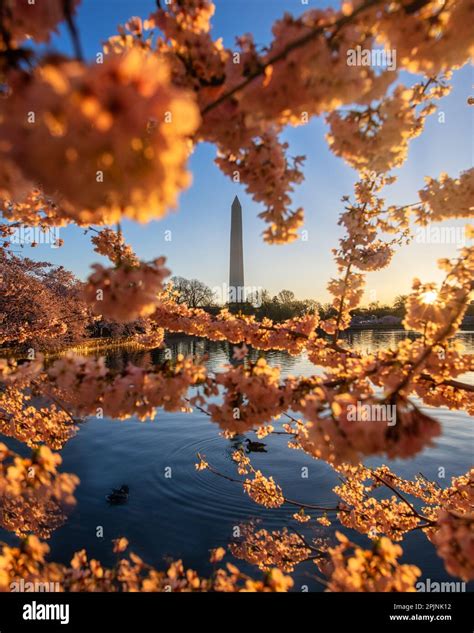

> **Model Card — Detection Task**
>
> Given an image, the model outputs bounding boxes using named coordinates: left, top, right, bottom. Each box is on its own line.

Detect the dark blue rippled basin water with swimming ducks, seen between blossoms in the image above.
left=0, top=330, right=474, bottom=591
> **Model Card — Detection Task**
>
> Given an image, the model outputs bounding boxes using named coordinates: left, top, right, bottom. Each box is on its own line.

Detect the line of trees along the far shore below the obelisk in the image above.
left=0, top=266, right=474, bottom=350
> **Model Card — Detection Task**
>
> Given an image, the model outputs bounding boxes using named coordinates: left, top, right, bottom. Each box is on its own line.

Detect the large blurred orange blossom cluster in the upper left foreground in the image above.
left=0, top=48, right=199, bottom=224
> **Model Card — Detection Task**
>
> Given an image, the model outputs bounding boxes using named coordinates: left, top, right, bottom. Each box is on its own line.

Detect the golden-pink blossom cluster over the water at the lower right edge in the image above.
left=334, top=465, right=474, bottom=580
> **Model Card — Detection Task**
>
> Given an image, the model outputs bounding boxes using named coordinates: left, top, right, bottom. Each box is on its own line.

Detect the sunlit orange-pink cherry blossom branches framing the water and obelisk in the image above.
left=0, top=0, right=474, bottom=592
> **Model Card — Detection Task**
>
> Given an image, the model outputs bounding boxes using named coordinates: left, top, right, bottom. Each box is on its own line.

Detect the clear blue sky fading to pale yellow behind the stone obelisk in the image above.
left=25, top=0, right=474, bottom=302
